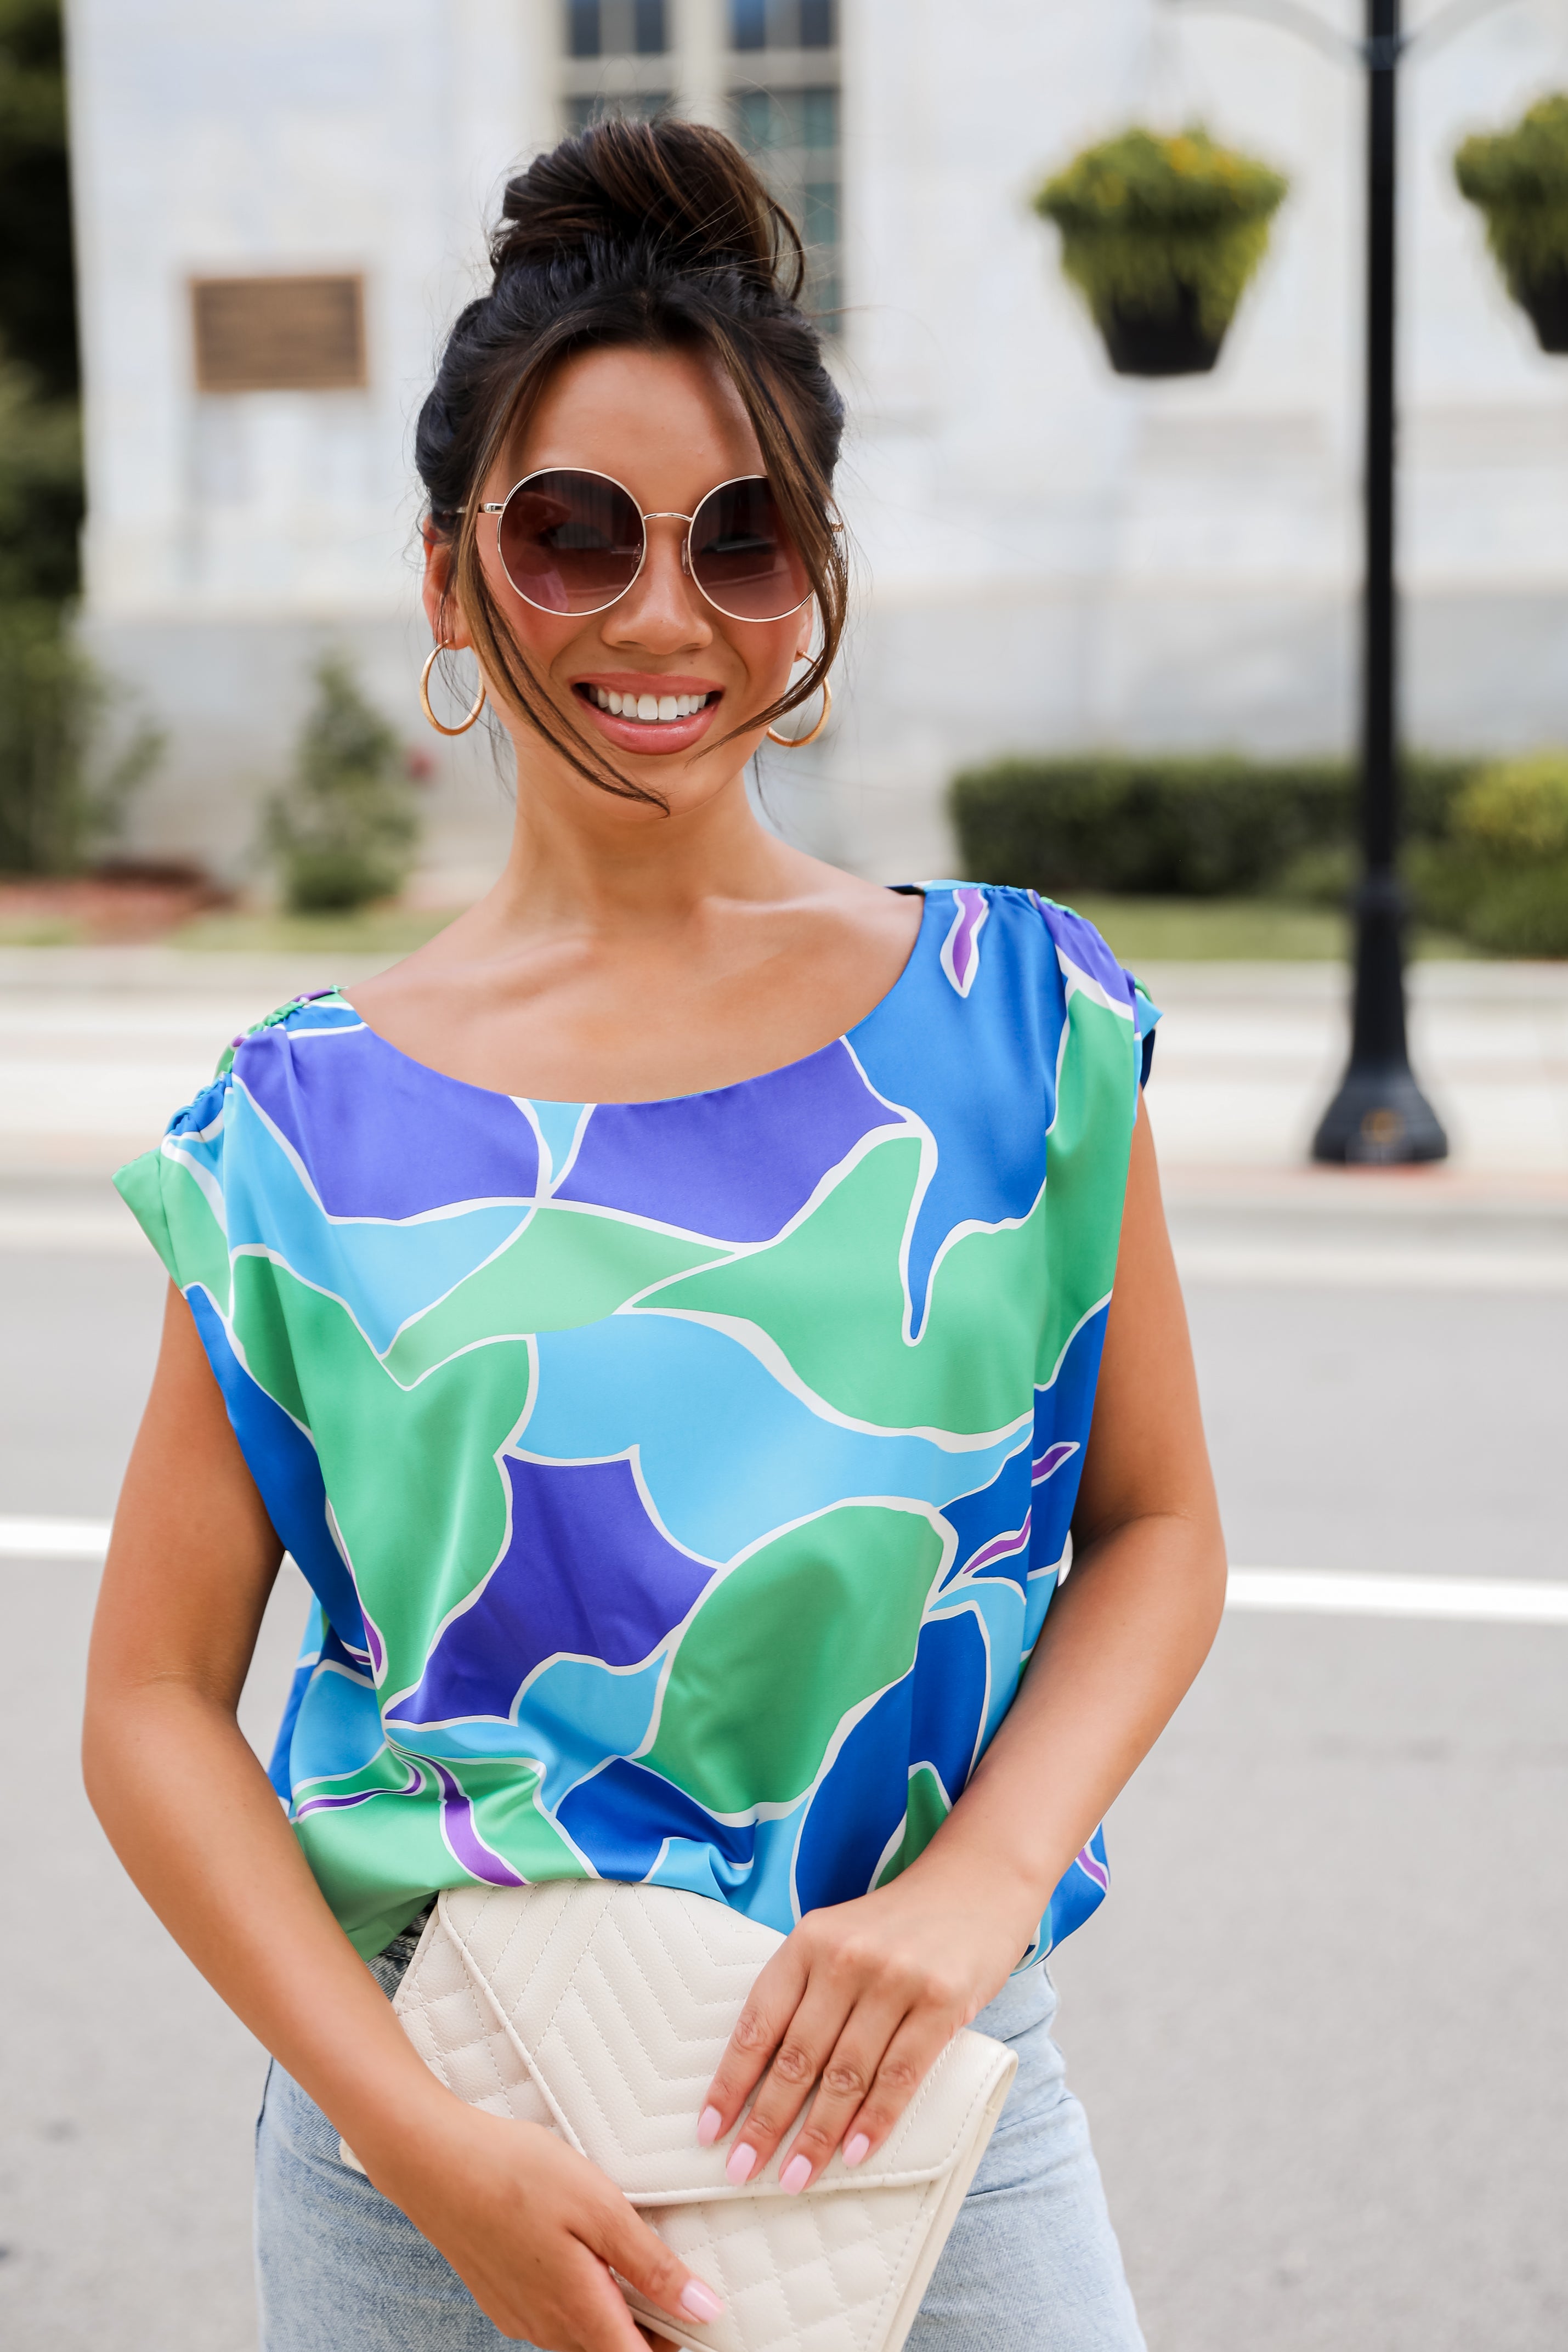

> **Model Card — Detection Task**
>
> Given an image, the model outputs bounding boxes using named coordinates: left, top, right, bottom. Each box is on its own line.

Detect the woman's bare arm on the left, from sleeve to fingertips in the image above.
left=82, top=1291, right=720, bottom=2352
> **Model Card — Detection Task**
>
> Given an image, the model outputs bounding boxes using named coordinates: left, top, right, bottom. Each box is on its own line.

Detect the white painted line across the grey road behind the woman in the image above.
left=0, top=1519, right=1568, bottom=1625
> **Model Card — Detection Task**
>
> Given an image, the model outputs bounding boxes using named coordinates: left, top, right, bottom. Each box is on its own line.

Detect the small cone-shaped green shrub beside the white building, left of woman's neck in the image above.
left=263, top=654, right=418, bottom=915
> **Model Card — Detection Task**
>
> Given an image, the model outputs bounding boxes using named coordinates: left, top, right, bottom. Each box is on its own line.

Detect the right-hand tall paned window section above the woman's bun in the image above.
left=729, top=0, right=842, bottom=329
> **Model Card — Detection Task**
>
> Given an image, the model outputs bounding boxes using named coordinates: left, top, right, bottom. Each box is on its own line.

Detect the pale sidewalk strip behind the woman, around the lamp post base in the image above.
left=0, top=948, right=1568, bottom=1289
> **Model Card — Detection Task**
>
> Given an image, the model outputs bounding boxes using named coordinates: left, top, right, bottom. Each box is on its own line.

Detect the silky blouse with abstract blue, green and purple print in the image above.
left=117, top=884, right=1154, bottom=1954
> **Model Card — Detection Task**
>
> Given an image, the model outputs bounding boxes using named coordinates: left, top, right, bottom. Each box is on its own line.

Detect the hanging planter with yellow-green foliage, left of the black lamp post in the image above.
left=1034, top=129, right=1288, bottom=376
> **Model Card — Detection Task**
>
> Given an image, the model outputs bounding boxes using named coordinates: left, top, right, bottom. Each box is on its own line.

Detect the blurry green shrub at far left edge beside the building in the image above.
left=0, top=597, right=162, bottom=875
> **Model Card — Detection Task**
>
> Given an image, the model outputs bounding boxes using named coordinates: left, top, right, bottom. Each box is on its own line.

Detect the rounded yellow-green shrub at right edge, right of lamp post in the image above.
left=1418, top=753, right=1568, bottom=955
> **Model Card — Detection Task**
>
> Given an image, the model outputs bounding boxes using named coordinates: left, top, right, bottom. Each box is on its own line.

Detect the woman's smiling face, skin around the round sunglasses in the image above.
left=426, top=350, right=811, bottom=818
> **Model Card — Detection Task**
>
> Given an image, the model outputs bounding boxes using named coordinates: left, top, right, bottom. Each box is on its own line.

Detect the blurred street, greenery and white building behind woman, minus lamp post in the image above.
left=0, top=0, right=1568, bottom=2352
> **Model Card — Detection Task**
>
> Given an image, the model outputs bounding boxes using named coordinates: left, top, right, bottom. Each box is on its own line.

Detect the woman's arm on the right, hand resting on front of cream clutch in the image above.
left=698, top=1103, right=1225, bottom=2187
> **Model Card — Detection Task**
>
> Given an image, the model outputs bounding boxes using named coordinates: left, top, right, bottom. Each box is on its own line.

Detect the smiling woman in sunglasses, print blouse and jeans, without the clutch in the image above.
left=87, top=122, right=1225, bottom=2352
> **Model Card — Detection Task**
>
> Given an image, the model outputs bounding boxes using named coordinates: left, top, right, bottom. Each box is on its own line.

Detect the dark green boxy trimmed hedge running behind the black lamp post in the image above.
left=950, top=753, right=1476, bottom=898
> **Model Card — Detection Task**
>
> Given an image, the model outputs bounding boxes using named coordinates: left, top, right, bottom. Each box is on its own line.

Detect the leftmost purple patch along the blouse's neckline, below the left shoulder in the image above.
left=235, top=1026, right=539, bottom=1218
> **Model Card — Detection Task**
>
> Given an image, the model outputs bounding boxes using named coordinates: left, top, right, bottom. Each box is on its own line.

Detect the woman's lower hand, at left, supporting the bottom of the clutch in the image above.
left=362, top=2100, right=724, bottom=2352
